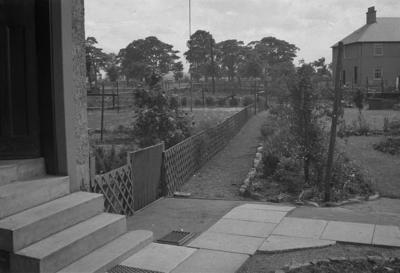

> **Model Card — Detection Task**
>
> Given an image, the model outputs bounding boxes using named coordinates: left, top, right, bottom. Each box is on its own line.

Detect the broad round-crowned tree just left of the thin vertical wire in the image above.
left=119, top=36, right=179, bottom=81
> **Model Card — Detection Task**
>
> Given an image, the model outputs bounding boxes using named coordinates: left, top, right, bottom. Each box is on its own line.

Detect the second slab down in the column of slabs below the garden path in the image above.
left=208, top=219, right=276, bottom=238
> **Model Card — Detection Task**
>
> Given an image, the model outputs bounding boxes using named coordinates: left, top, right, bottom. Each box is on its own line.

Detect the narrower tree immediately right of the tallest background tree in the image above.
left=216, top=40, right=244, bottom=81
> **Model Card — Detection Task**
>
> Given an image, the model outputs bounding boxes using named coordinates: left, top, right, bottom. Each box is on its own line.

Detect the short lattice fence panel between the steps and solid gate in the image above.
left=91, top=165, right=134, bottom=215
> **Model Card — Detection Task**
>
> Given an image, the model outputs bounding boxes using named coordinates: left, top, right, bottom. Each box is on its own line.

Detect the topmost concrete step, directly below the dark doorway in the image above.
left=0, top=158, right=46, bottom=186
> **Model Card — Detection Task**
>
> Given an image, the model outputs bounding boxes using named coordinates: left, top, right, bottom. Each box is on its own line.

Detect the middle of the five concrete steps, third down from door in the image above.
left=0, top=192, right=104, bottom=252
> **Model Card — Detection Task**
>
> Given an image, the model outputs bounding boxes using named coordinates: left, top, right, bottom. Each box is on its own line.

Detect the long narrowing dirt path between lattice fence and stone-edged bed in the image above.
left=181, top=109, right=268, bottom=200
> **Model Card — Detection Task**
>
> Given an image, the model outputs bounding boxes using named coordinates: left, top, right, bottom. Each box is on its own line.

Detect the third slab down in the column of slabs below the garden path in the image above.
left=188, top=231, right=265, bottom=255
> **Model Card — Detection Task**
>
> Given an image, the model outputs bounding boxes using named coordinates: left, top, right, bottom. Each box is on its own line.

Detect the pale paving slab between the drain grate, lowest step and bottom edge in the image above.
left=121, top=243, right=196, bottom=273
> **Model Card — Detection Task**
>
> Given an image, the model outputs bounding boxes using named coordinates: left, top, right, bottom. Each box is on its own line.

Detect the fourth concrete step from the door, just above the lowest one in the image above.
left=10, top=213, right=126, bottom=273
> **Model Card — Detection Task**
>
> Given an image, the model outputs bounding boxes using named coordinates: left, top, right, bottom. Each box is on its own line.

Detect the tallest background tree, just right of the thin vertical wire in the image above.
left=184, top=30, right=215, bottom=81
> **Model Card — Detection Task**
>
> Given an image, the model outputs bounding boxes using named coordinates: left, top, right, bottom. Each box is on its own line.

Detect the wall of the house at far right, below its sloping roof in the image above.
left=332, top=42, right=400, bottom=87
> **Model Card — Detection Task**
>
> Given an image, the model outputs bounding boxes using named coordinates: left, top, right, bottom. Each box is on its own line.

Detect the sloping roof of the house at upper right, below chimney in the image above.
left=333, top=17, right=400, bottom=47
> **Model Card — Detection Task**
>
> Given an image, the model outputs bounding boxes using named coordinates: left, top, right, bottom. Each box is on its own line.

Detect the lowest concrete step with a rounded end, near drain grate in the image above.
left=58, top=230, right=153, bottom=273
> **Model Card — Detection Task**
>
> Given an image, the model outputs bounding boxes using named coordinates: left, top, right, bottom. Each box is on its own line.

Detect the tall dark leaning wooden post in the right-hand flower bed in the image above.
left=324, top=42, right=343, bottom=202
